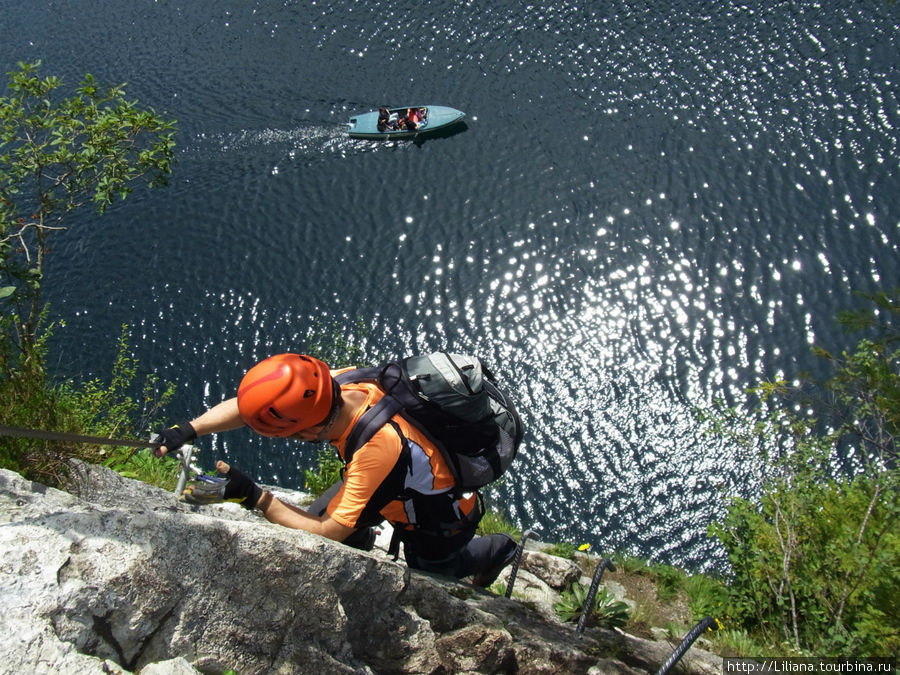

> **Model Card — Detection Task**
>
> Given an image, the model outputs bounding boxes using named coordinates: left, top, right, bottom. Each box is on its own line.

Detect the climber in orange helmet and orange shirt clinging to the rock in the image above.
left=155, top=354, right=517, bottom=587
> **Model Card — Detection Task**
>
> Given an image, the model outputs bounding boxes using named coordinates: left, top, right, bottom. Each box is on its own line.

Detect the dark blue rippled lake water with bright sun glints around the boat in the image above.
left=0, top=0, right=900, bottom=568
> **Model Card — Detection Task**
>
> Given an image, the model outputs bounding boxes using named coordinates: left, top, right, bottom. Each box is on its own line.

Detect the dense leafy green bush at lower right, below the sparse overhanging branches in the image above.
left=713, top=477, right=900, bottom=656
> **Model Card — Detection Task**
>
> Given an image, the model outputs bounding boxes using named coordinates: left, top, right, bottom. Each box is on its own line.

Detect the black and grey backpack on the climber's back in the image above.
left=334, top=352, right=522, bottom=492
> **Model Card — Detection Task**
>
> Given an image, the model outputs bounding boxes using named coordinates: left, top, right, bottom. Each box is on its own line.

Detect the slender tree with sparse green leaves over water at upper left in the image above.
left=0, top=61, right=175, bottom=353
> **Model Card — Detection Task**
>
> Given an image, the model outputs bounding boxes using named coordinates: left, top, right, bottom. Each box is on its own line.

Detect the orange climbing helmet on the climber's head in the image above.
left=238, top=354, right=334, bottom=436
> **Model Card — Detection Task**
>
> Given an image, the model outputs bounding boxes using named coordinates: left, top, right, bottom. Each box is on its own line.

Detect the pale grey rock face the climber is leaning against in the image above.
left=0, top=465, right=721, bottom=675
